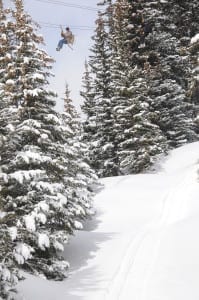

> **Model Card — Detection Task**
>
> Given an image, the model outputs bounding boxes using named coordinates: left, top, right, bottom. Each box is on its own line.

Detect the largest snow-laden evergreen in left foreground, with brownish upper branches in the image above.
left=0, top=0, right=95, bottom=292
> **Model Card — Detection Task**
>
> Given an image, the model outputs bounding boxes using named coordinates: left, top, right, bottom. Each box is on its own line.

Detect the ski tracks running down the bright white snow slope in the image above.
left=103, top=166, right=197, bottom=300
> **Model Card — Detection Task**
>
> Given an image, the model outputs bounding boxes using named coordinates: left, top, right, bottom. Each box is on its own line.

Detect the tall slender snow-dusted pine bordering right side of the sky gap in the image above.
left=84, top=13, right=116, bottom=176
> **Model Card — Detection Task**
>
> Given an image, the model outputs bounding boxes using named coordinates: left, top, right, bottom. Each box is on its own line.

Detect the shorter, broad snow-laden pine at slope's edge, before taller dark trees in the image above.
left=116, top=70, right=168, bottom=174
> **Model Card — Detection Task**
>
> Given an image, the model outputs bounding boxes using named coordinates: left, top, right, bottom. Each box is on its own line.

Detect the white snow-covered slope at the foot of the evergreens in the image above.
left=18, top=143, right=199, bottom=300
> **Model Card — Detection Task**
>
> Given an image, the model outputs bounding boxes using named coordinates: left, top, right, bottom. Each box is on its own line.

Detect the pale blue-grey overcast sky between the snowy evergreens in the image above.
left=4, top=0, right=99, bottom=111
